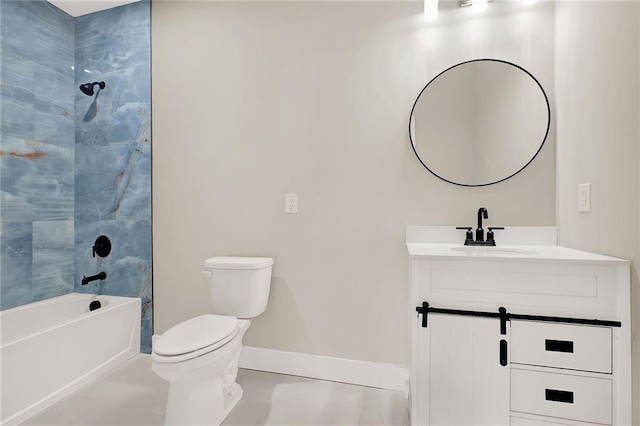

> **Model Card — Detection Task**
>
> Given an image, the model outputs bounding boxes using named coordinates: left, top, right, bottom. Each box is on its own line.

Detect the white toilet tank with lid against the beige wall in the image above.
left=204, top=257, right=273, bottom=318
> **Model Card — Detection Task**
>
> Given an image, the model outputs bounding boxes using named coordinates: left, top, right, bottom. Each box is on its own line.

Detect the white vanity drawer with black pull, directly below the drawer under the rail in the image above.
left=511, top=368, right=611, bottom=424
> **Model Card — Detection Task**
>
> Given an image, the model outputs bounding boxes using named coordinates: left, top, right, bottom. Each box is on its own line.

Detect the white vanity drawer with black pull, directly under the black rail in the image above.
left=511, top=320, right=611, bottom=373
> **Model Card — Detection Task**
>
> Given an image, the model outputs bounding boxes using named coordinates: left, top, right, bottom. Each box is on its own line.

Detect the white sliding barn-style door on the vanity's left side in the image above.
left=419, top=315, right=509, bottom=425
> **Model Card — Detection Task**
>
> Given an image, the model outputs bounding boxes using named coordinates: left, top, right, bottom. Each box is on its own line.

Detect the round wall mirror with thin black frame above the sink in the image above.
left=409, top=59, right=551, bottom=186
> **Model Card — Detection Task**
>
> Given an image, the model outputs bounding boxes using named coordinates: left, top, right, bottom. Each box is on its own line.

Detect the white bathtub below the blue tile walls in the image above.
left=0, top=293, right=140, bottom=426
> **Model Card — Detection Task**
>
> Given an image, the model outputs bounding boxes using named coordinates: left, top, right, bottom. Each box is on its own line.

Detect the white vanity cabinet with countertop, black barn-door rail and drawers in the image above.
left=407, top=226, right=631, bottom=425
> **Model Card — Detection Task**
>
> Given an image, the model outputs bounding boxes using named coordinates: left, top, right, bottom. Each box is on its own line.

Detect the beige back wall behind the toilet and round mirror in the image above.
left=152, top=2, right=556, bottom=365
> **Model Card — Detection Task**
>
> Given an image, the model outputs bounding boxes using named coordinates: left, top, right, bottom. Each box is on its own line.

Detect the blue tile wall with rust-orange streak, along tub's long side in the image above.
left=0, top=1, right=75, bottom=309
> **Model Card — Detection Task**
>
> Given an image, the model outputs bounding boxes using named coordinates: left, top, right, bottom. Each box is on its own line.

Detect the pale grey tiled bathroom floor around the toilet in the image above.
left=23, top=355, right=409, bottom=426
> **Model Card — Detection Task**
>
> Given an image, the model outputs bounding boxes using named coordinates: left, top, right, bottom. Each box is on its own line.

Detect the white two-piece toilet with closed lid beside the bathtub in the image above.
left=151, top=257, right=273, bottom=425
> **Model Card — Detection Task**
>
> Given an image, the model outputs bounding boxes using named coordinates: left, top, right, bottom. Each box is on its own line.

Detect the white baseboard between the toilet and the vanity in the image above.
left=240, top=346, right=409, bottom=395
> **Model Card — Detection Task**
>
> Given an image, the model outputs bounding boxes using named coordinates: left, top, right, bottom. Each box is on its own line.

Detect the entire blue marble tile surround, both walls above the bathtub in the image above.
left=0, top=0, right=152, bottom=352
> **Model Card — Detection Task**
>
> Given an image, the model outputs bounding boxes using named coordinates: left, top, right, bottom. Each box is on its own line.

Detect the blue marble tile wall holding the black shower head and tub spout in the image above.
left=74, top=1, right=153, bottom=352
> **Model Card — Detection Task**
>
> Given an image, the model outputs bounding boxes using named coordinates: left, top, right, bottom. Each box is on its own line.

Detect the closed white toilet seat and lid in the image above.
left=152, top=315, right=239, bottom=363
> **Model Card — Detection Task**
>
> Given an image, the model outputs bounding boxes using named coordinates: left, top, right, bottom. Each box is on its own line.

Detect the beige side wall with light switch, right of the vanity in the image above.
left=556, top=2, right=640, bottom=424
